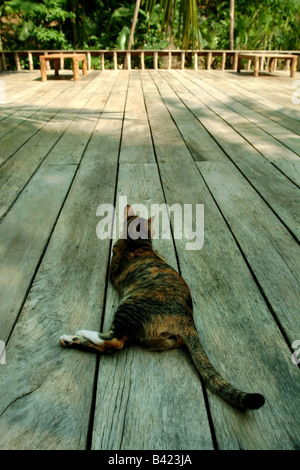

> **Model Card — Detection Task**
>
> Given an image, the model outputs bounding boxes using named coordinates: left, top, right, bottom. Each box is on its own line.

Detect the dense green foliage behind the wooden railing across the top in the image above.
left=0, top=0, right=300, bottom=50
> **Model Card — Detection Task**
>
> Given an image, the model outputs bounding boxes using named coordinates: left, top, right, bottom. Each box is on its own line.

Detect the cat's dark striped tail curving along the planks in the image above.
left=182, top=327, right=265, bottom=410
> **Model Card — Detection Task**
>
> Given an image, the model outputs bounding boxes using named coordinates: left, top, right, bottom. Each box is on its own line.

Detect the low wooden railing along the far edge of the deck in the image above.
left=0, top=49, right=300, bottom=71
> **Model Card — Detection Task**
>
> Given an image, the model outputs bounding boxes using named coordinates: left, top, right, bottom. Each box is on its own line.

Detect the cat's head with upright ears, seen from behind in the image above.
left=121, top=205, right=155, bottom=244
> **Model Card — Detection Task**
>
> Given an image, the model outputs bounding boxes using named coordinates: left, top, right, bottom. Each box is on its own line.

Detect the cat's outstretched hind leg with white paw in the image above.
left=59, top=330, right=127, bottom=353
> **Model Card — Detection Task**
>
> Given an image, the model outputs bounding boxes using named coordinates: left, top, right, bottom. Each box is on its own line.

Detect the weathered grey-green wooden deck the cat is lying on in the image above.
left=0, top=70, right=300, bottom=450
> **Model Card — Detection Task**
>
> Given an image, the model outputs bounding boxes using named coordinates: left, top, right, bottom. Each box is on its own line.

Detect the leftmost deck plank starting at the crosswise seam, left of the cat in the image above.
left=0, top=166, right=75, bottom=341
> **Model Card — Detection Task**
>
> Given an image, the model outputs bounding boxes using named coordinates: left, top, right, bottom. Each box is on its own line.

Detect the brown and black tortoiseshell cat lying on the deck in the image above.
left=60, top=206, right=265, bottom=410
